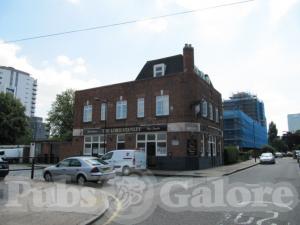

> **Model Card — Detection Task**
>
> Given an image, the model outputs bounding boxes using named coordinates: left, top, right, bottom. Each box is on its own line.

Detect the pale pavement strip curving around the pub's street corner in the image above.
left=150, top=159, right=259, bottom=177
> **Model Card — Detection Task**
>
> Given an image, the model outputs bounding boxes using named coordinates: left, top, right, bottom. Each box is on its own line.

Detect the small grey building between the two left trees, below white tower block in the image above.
left=30, top=116, right=49, bottom=141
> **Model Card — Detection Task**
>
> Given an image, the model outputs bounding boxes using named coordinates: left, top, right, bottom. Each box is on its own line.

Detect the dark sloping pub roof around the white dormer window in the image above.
left=136, top=55, right=183, bottom=80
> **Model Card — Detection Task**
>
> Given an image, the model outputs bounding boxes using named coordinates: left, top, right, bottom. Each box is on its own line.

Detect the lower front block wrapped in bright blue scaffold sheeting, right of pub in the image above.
left=224, top=110, right=268, bottom=149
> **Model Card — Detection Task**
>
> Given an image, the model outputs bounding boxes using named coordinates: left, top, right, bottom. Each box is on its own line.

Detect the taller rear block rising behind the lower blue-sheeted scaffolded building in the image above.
left=223, top=92, right=267, bottom=127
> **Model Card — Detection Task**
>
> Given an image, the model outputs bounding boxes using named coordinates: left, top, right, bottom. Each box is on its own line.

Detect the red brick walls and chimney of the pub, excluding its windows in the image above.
left=73, top=45, right=223, bottom=169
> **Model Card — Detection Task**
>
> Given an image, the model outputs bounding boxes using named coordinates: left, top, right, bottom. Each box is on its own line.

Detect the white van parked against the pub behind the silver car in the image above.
left=101, top=149, right=146, bottom=176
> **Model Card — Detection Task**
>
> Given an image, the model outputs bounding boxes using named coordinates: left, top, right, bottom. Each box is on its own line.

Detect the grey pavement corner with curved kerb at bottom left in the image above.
left=0, top=178, right=109, bottom=225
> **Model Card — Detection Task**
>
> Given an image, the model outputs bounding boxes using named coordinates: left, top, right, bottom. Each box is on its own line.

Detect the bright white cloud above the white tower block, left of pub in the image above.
left=0, top=41, right=100, bottom=117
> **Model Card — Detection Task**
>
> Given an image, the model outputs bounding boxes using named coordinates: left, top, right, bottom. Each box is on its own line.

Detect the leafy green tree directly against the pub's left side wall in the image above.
left=47, top=89, right=74, bottom=141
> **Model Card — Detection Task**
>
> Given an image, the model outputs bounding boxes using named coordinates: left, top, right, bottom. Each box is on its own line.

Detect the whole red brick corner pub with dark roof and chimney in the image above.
left=73, top=44, right=223, bottom=170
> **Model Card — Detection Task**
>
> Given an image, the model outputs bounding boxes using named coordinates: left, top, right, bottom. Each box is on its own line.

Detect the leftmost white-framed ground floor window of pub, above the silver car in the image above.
left=83, top=135, right=105, bottom=156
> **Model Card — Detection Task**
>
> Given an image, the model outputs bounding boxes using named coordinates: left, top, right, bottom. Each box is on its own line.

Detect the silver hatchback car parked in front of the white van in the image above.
left=44, top=156, right=116, bottom=185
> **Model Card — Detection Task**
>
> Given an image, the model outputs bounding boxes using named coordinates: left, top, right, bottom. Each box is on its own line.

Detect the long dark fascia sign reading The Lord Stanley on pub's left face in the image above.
left=83, top=125, right=167, bottom=135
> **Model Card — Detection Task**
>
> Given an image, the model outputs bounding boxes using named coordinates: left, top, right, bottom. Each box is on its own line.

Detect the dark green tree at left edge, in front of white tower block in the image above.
left=0, top=93, right=29, bottom=145
